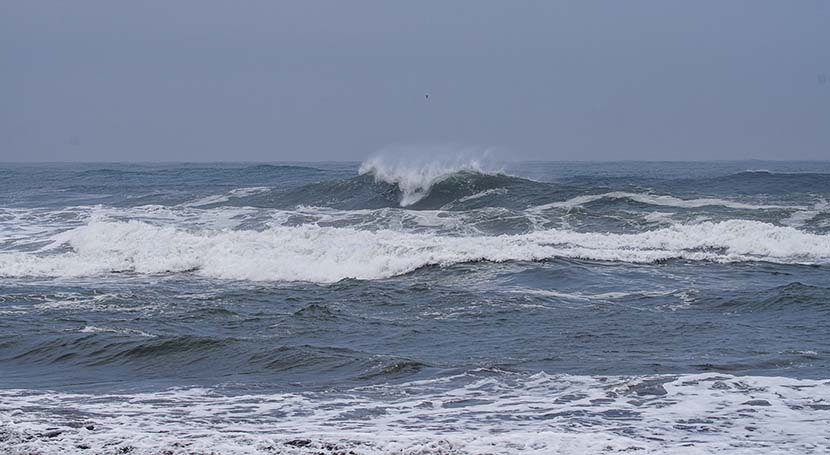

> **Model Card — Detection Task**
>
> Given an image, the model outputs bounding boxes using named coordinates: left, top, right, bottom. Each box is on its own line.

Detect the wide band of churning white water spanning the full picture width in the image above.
left=0, top=220, right=830, bottom=283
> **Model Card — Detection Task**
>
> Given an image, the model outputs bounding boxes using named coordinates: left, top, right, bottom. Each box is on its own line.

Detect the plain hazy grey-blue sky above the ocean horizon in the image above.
left=0, top=0, right=830, bottom=162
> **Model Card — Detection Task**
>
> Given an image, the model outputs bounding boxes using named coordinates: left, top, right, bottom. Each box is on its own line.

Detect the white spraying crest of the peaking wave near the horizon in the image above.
left=359, top=148, right=498, bottom=207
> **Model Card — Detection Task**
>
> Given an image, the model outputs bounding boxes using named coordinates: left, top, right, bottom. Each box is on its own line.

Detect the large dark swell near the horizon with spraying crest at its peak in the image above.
left=174, top=169, right=830, bottom=216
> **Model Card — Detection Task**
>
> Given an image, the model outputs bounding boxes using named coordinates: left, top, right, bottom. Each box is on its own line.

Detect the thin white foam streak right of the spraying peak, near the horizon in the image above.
left=528, top=191, right=806, bottom=212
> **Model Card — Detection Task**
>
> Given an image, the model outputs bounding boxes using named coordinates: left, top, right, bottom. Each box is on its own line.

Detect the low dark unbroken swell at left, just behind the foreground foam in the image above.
left=2, top=331, right=436, bottom=384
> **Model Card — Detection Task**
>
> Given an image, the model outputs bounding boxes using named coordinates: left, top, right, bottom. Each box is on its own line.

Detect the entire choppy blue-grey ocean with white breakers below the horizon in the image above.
left=0, top=159, right=830, bottom=455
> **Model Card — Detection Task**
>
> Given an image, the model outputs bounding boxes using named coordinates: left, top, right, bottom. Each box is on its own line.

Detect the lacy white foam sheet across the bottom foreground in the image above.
left=0, top=373, right=830, bottom=455
